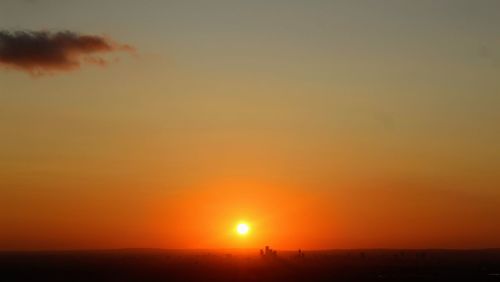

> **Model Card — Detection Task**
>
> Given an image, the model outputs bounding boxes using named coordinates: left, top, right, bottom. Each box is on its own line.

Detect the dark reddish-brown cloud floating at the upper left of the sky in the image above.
left=0, top=31, right=134, bottom=75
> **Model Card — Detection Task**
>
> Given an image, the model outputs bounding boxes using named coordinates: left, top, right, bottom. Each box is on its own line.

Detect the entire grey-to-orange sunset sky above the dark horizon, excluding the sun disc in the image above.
left=0, top=0, right=500, bottom=250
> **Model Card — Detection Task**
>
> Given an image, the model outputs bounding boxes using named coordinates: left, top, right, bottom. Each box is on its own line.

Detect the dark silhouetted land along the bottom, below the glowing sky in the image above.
left=0, top=250, right=500, bottom=282
